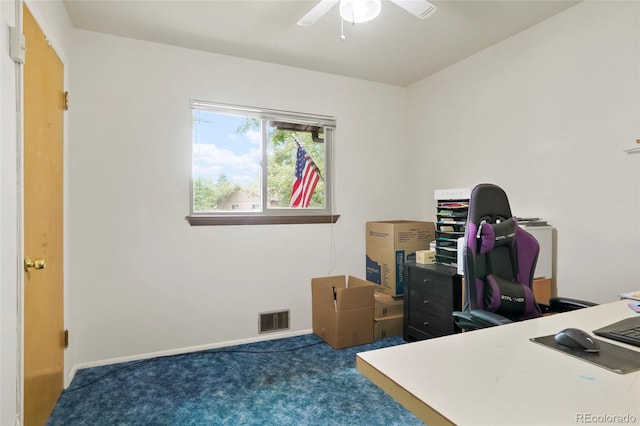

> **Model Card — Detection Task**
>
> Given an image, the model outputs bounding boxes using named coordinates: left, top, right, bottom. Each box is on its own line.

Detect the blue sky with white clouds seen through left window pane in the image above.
left=193, top=110, right=261, bottom=185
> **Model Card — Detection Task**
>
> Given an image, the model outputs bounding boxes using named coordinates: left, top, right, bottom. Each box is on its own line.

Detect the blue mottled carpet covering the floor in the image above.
left=47, top=334, right=422, bottom=426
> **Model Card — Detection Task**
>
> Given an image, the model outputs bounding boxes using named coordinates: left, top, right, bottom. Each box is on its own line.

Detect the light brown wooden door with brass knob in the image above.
left=23, top=6, right=64, bottom=426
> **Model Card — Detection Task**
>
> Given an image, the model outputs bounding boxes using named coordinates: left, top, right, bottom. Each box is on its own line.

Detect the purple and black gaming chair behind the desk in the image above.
left=453, top=183, right=594, bottom=330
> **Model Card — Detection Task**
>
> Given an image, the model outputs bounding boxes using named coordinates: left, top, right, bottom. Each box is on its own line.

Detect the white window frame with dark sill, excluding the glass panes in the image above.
left=186, top=99, right=340, bottom=226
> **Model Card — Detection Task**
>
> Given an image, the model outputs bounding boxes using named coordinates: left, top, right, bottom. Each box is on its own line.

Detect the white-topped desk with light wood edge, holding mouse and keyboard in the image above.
left=356, top=300, right=640, bottom=426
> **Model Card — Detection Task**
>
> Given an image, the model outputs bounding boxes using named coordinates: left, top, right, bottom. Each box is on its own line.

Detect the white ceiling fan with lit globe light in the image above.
left=298, top=0, right=437, bottom=27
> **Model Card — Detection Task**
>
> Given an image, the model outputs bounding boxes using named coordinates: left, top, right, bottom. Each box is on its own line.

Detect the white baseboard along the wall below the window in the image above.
left=64, top=330, right=313, bottom=389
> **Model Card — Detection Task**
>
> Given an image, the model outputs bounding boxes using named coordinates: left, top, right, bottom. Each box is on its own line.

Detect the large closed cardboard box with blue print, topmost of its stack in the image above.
left=366, top=220, right=435, bottom=296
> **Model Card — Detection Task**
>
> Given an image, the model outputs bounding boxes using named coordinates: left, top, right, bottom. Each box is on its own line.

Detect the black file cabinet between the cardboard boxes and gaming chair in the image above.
left=403, top=263, right=462, bottom=342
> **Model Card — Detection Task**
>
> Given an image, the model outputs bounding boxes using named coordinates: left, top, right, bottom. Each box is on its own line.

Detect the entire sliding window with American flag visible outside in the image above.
left=188, top=100, right=339, bottom=225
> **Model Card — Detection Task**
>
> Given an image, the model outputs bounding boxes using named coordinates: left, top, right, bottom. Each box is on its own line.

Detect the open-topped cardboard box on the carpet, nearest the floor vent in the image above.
left=311, top=275, right=376, bottom=349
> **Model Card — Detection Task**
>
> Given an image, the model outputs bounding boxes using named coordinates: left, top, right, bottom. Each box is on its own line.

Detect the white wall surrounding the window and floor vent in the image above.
left=67, top=30, right=410, bottom=365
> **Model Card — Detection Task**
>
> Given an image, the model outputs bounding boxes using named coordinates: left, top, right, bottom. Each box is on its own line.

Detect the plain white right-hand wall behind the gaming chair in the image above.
left=408, top=2, right=640, bottom=302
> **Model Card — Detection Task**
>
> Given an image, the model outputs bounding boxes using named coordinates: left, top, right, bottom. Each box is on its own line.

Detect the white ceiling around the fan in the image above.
left=64, top=0, right=578, bottom=86
